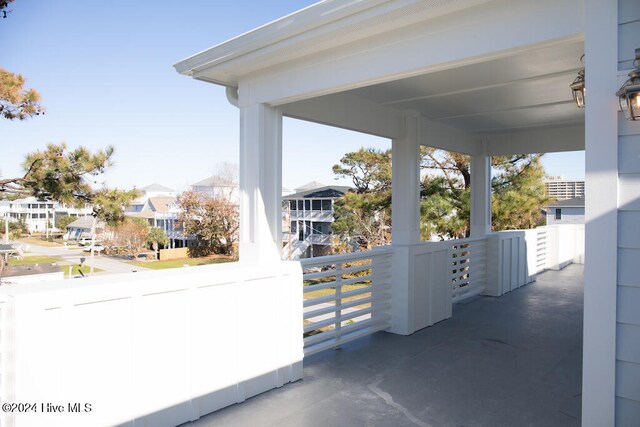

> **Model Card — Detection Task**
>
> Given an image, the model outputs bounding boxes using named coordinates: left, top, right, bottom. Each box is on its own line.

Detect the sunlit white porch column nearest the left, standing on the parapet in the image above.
left=240, top=104, right=282, bottom=263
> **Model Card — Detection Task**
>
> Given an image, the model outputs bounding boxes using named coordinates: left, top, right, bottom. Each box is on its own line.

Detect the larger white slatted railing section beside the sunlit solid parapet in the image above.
left=301, top=248, right=392, bottom=355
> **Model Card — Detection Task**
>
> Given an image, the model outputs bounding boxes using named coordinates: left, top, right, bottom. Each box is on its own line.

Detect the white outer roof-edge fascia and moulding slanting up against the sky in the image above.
left=174, top=0, right=491, bottom=86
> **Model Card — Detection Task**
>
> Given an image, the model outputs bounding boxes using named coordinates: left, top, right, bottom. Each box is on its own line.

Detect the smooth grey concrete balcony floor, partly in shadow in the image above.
left=187, top=265, right=583, bottom=427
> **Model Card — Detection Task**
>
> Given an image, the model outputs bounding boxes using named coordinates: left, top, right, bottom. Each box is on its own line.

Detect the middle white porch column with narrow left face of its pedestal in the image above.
left=391, top=116, right=420, bottom=335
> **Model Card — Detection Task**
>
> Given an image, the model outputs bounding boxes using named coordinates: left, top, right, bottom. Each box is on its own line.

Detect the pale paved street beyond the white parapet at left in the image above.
left=15, top=242, right=150, bottom=274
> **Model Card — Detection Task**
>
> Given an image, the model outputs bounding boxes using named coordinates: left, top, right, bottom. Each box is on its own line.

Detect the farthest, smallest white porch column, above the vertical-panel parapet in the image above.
left=471, top=154, right=491, bottom=237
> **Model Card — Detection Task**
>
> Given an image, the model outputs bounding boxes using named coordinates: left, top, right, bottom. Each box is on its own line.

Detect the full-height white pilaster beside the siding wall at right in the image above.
left=582, top=0, right=620, bottom=427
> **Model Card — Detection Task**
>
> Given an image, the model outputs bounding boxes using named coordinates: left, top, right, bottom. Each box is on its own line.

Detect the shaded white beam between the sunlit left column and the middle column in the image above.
left=280, top=93, right=402, bottom=139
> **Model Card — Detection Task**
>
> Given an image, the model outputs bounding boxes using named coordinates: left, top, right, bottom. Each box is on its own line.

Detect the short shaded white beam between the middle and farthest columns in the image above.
left=419, top=117, right=482, bottom=156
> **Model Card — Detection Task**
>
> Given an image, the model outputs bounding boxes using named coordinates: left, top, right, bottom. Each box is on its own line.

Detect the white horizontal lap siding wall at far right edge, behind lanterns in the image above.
left=616, top=0, right=640, bottom=426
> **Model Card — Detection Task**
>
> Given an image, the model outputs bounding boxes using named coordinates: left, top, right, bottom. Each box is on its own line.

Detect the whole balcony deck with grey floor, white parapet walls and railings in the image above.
left=0, top=225, right=584, bottom=427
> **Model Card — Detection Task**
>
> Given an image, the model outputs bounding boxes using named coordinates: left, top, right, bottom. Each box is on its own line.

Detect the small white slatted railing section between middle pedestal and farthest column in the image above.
left=451, top=237, right=487, bottom=303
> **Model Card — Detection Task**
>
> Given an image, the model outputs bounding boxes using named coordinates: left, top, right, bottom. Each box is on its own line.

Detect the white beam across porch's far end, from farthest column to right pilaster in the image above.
left=483, top=124, right=584, bottom=156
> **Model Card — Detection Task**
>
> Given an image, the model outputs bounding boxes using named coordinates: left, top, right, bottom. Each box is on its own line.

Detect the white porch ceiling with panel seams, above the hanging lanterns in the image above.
left=349, top=40, right=584, bottom=134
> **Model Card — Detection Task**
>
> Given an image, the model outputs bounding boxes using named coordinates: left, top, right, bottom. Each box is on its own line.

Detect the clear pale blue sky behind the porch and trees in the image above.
left=0, top=0, right=584, bottom=190
